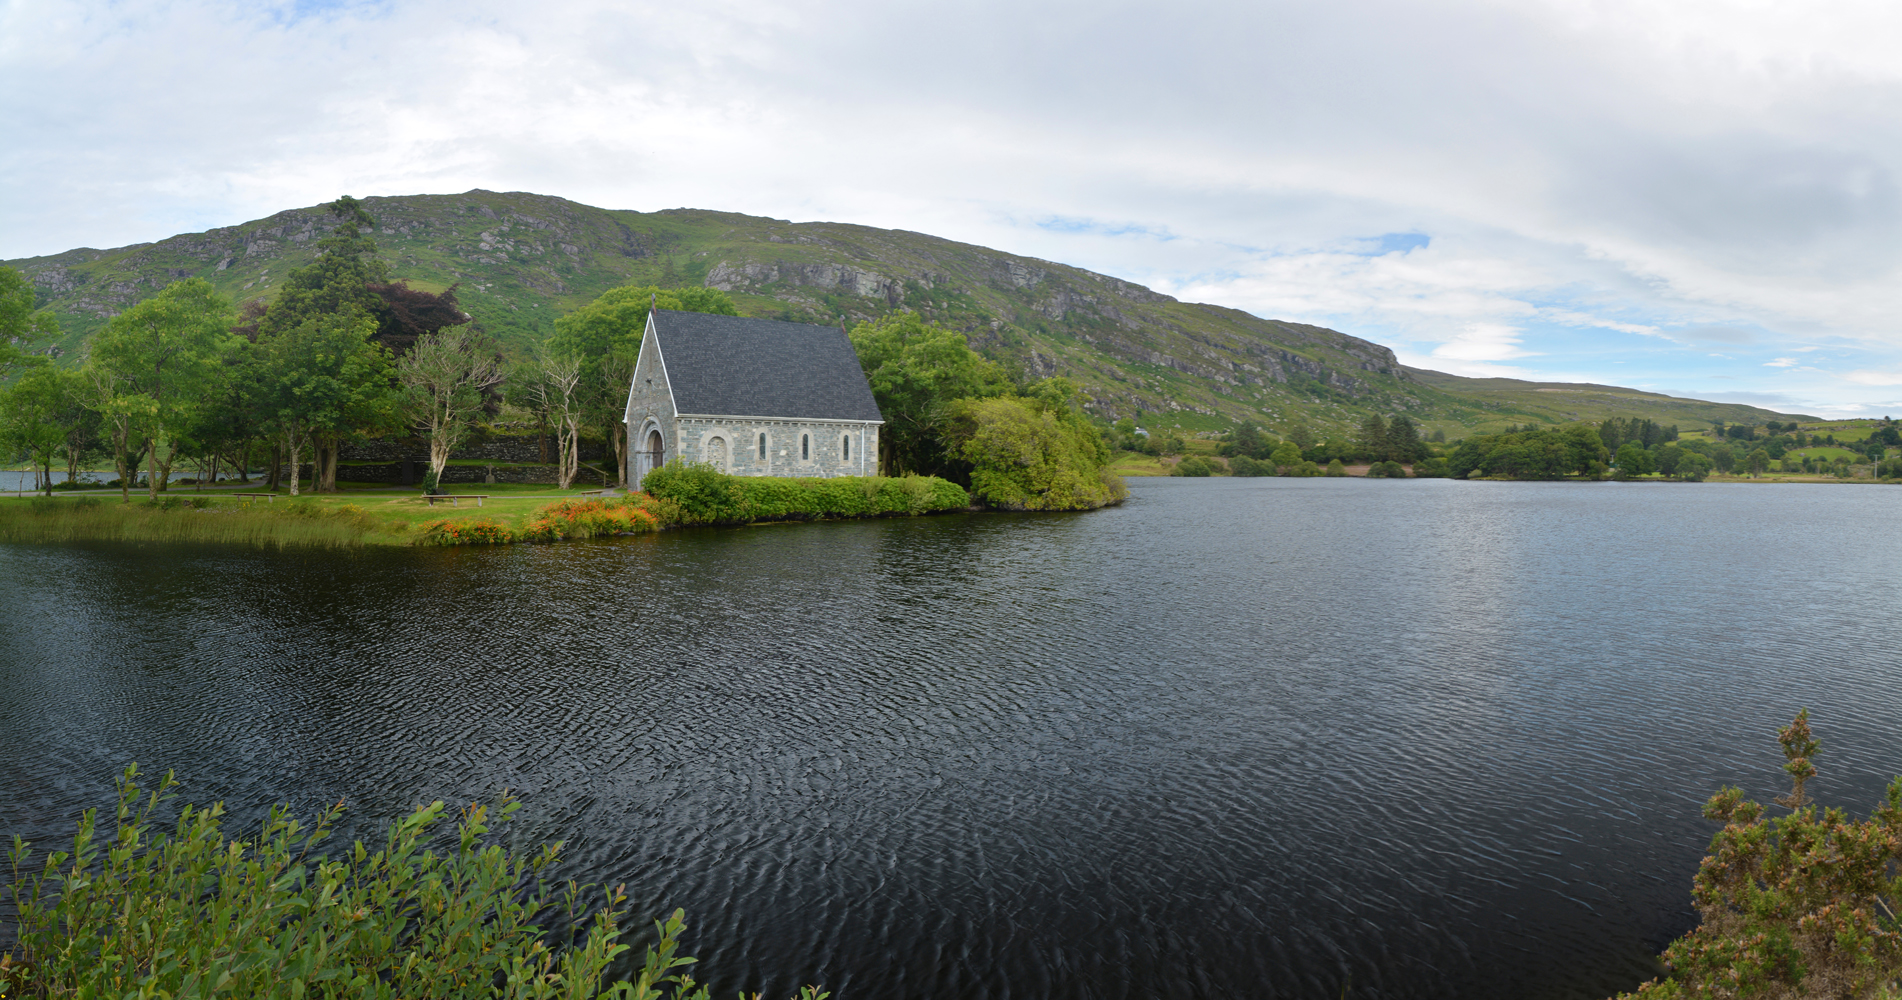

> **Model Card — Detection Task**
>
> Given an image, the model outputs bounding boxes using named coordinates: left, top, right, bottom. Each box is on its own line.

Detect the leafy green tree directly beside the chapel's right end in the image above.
left=852, top=312, right=1012, bottom=479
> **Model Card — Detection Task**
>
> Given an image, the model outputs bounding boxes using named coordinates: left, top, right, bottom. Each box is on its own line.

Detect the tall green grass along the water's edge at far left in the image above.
left=0, top=496, right=377, bottom=549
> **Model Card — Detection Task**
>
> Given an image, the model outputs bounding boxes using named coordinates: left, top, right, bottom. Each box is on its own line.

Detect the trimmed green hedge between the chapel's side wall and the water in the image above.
left=641, top=462, right=970, bottom=525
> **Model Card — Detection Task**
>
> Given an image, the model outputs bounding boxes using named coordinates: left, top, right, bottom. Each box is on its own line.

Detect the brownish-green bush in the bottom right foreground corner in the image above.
left=1621, top=711, right=1902, bottom=1000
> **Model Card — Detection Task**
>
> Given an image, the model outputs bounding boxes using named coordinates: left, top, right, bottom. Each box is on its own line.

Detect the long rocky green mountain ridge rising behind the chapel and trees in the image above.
left=4, top=190, right=1792, bottom=437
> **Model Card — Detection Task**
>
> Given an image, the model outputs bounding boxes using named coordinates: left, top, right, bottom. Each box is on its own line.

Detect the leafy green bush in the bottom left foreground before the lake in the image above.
left=0, top=766, right=825, bottom=1000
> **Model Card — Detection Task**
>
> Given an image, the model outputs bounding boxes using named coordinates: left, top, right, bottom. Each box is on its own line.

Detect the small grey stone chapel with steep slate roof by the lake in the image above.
left=626, top=310, right=884, bottom=489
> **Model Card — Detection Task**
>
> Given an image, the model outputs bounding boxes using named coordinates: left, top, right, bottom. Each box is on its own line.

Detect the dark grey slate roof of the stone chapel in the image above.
left=654, top=310, right=884, bottom=420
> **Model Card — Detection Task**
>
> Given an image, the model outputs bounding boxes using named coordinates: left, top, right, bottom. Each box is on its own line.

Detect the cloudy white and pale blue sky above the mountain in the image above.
left=0, top=0, right=1902, bottom=416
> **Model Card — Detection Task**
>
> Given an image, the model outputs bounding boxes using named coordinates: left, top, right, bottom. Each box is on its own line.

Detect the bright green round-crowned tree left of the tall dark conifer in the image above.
left=91, top=278, right=230, bottom=498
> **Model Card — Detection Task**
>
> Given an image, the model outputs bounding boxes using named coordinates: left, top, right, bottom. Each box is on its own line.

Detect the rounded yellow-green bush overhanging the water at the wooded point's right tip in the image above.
left=951, top=393, right=1128, bottom=510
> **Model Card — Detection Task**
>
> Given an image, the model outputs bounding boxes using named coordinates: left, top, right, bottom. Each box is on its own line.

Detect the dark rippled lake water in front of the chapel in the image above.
left=0, top=479, right=1902, bottom=1000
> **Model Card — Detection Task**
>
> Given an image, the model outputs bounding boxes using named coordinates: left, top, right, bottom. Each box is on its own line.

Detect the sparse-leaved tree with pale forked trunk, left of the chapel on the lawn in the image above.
left=396, top=327, right=502, bottom=494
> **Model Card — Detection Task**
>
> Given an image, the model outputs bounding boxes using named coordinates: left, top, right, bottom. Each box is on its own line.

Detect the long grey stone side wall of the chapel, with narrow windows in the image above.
left=677, top=416, right=879, bottom=477
